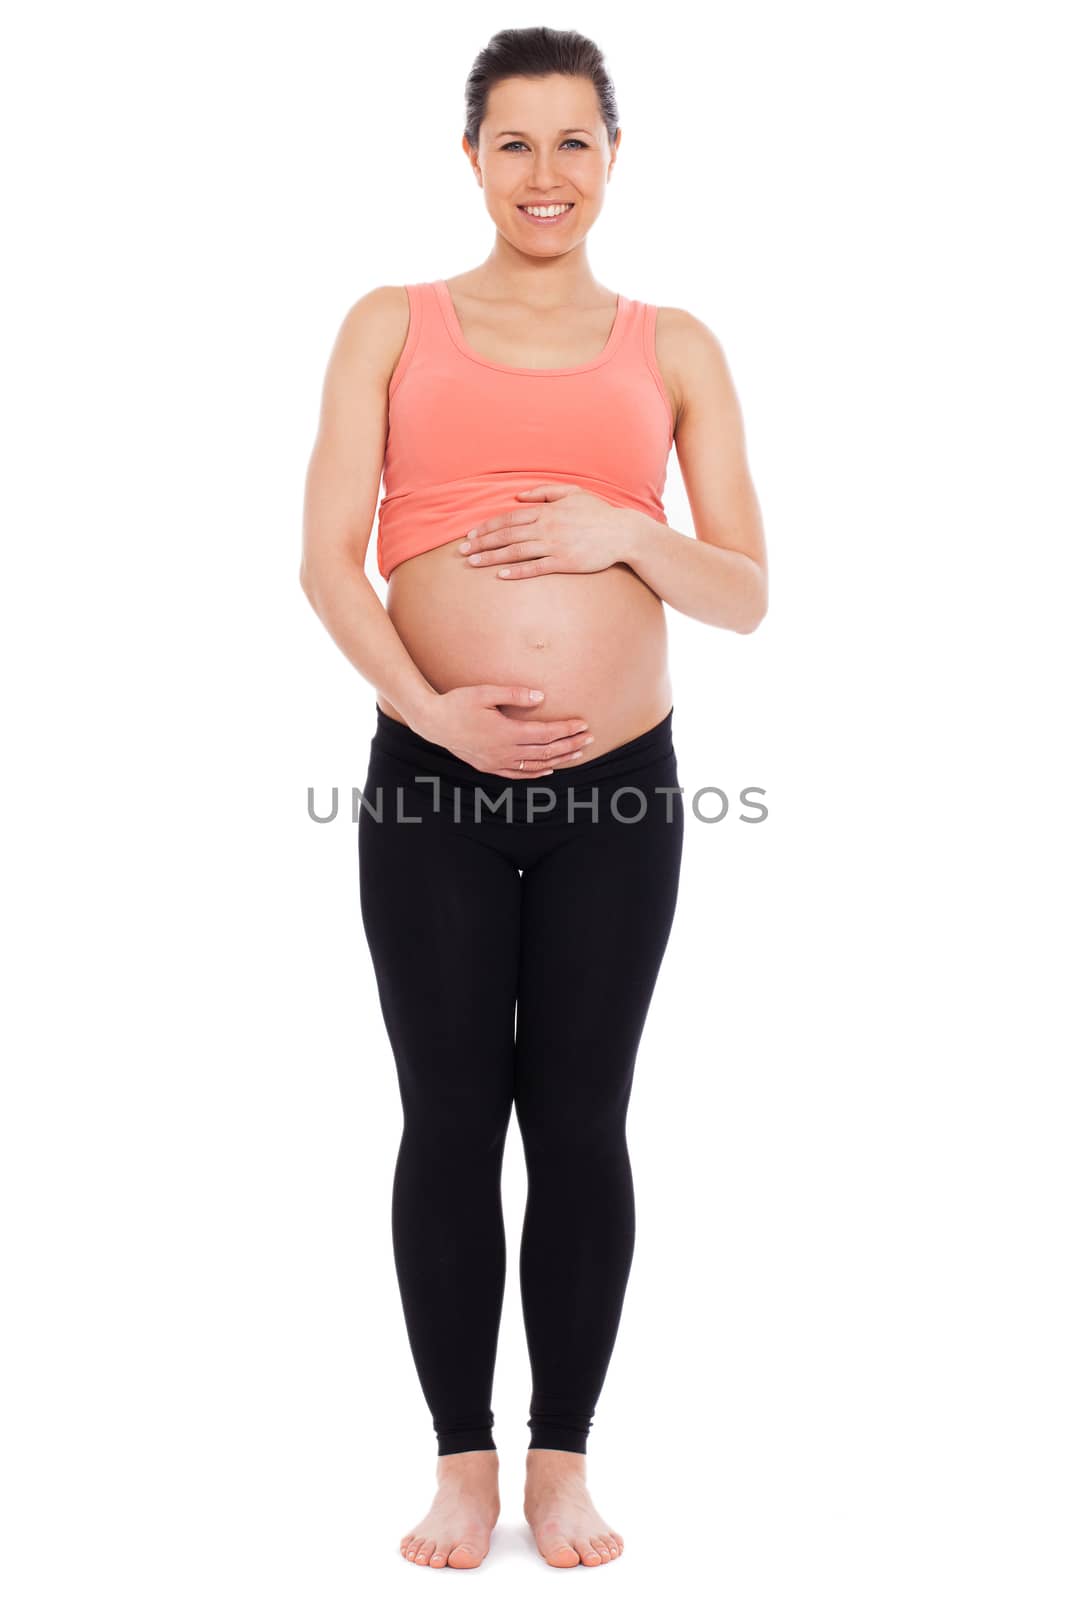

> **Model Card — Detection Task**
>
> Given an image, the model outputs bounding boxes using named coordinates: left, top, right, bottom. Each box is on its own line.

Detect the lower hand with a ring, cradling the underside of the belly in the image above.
left=413, top=683, right=592, bottom=778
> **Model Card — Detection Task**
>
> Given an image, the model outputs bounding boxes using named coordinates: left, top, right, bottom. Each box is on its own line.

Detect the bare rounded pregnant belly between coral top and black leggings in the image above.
left=378, top=544, right=672, bottom=766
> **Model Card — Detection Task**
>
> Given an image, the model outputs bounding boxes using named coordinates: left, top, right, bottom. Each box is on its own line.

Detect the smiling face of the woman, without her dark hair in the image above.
left=464, top=74, right=619, bottom=256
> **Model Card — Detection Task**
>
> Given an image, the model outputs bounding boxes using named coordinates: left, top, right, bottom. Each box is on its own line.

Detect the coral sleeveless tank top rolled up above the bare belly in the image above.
left=378, top=278, right=673, bottom=578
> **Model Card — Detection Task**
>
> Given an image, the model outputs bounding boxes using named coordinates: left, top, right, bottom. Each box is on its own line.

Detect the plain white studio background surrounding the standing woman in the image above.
left=0, top=0, right=1067, bottom=1600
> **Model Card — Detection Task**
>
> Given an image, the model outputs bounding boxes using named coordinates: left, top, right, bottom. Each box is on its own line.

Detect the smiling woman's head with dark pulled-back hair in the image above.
left=464, top=27, right=621, bottom=254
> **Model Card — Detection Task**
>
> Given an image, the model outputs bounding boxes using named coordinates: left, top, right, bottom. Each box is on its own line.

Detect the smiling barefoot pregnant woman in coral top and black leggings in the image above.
left=301, top=27, right=766, bottom=1568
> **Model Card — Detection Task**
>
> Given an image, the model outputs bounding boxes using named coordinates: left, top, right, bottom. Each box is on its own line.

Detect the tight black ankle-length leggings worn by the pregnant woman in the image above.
left=358, top=707, right=683, bottom=1456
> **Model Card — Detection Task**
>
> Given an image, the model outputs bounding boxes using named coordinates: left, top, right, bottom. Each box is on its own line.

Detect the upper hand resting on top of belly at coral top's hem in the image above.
left=459, top=483, right=633, bottom=578
